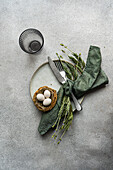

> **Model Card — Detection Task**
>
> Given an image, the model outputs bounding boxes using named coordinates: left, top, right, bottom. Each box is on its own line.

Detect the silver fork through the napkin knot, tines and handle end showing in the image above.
left=54, top=61, right=82, bottom=111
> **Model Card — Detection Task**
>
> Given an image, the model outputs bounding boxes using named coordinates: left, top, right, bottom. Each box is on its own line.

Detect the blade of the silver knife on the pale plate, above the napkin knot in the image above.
left=48, top=57, right=65, bottom=84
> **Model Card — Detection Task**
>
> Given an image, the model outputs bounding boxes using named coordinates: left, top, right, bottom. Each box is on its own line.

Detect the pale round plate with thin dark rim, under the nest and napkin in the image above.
left=30, top=60, right=83, bottom=109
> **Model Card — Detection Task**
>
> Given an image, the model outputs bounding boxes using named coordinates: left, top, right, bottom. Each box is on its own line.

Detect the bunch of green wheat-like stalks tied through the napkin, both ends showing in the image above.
left=52, top=44, right=85, bottom=144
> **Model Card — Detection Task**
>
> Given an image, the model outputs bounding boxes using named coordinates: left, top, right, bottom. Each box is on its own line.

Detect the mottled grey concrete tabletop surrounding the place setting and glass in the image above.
left=0, top=0, right=113, bottom=170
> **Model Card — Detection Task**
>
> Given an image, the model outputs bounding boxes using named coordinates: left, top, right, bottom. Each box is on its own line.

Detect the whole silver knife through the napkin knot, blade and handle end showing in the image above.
left=48, top=57, right=82, bottom=111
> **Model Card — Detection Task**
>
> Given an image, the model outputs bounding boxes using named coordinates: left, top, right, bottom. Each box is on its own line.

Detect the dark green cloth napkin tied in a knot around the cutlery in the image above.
left=38, top=46, right=108, bottom=135
